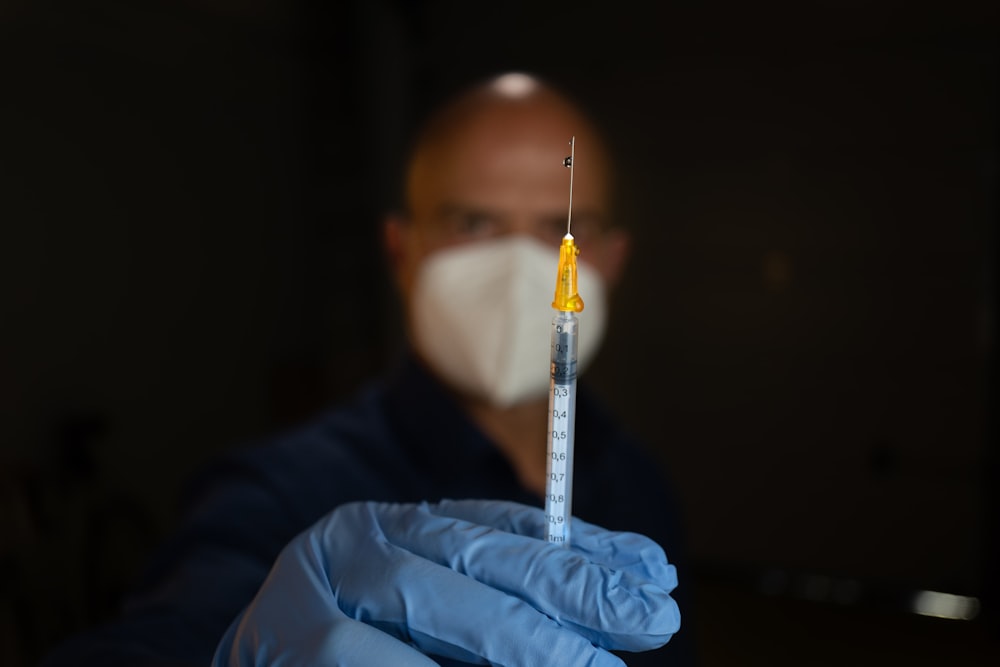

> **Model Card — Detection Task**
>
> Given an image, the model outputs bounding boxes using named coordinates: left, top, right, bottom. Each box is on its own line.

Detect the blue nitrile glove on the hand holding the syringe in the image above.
left=213, top=500, right=680, bottom=667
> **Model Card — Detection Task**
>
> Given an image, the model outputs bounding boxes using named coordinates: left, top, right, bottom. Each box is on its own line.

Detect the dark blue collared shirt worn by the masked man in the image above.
left=44, top=361, right=691, bottom=667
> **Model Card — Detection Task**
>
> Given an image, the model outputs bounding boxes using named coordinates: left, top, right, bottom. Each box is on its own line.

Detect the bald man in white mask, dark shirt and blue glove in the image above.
left=48, top=75, right=683, bottom=666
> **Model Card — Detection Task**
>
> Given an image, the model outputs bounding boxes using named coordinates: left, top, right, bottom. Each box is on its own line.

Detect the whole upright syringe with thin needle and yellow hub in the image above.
left=545, top=137, right=583, bottom=547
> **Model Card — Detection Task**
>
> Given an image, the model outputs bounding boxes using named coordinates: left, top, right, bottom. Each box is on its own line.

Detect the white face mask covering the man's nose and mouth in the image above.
left=410, top=236, right=607, bottom=407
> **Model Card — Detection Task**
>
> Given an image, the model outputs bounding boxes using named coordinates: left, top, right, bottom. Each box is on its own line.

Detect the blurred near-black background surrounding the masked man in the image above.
left=0, top=0, right=1000, bottom=666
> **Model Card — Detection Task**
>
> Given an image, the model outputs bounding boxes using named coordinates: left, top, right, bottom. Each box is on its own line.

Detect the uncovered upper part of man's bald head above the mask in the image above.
left=386, top=74, right=625, bottom=300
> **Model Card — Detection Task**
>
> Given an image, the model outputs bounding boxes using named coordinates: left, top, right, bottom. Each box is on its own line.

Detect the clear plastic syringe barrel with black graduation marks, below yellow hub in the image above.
left=545, top=311, right=580, bottom=547
